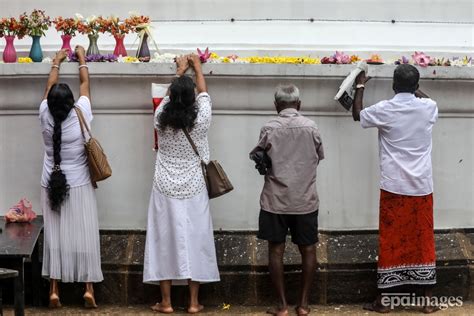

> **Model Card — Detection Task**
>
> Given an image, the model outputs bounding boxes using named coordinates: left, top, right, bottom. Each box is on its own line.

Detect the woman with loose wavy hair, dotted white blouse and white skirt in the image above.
left=143, top=55, right=220, bottom=313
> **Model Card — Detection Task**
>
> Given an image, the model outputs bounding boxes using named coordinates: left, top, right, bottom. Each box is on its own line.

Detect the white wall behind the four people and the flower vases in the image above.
left=0, top=0, right=474, bottom=230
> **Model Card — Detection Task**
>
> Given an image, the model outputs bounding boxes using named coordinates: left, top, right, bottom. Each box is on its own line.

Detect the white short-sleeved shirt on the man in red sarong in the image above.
left=360, top=93, right=438, bottom=196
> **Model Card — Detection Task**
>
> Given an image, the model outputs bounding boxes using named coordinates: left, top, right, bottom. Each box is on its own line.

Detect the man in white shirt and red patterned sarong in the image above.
left=352, top=65, right=438, bottom=313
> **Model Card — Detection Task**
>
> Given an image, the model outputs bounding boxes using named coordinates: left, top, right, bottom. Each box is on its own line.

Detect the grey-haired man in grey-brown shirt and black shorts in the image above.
left=250, top=85, right=324, bottom=316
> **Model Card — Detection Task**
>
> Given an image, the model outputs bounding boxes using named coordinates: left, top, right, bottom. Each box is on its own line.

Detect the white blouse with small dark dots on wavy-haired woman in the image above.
left=153, top=92, right=212, bottom=199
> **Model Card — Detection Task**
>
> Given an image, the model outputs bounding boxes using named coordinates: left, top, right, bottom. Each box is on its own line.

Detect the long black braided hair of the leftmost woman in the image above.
left=48, top=83, right=74, bottom=212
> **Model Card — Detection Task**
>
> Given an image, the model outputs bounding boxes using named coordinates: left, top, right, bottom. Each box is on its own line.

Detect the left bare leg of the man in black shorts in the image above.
left=267, top=241, right=288, bottom=316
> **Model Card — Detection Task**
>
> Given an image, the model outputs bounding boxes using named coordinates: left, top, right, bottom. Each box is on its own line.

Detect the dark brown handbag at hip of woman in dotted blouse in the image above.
left=183, top=128, right=234, bottom=199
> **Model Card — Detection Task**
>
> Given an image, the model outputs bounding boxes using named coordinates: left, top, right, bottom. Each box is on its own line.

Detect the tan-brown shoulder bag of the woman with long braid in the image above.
left=74, top=107, right=112, bottom=188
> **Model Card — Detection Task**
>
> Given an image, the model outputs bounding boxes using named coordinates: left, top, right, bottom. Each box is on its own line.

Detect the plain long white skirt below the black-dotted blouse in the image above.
left=143, top=186, right=220, bottom=285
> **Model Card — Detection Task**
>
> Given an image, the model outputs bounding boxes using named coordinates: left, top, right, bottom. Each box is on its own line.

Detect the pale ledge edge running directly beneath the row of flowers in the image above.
left=0, top=63, right=474, bottom=80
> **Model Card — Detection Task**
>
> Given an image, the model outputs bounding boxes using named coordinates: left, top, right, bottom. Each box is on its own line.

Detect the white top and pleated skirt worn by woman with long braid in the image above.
left=39, top=96, right=104, bottom=282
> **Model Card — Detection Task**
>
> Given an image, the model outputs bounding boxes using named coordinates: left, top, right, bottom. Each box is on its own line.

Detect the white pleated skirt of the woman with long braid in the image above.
left=41, top=184, right=104, bottom=282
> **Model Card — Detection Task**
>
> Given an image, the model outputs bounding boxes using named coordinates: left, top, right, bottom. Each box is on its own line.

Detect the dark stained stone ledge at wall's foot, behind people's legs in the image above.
left=1, top=229, right=468, bottom=305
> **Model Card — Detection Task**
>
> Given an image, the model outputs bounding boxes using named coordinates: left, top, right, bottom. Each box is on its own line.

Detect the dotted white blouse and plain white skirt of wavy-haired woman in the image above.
left=143, top=93, right=220, bottom=285
